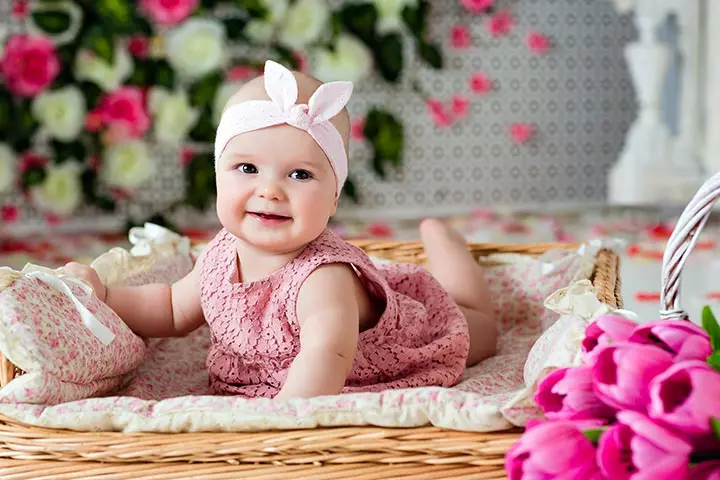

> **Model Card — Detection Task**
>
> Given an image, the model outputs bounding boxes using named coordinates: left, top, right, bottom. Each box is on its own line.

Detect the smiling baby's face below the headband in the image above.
left=216, top=125, right=337, bottom=254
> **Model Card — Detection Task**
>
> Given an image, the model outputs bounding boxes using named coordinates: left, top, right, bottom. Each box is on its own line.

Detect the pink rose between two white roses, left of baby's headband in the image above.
left=99, top=87, right=150, bottom=141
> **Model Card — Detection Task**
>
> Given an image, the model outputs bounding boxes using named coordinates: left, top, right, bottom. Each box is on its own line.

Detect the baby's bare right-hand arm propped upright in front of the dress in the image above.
left=275, top=264, right=360, bottom=400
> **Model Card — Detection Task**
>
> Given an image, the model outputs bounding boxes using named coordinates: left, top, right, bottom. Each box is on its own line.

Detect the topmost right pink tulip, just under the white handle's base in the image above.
left=628, top=320, right=712, bottom=361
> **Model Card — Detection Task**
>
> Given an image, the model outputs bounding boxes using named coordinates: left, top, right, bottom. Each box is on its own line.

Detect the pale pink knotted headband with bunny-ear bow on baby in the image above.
left=215, top=60, right=353, bottom=195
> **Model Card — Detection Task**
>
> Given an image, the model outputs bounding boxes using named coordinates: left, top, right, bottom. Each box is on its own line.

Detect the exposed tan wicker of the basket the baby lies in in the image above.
left=0, top=241, right=622, bottom=480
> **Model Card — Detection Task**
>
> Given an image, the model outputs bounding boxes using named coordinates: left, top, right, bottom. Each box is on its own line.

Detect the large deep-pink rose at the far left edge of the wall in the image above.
left=0, top=35, right=60, bottom=97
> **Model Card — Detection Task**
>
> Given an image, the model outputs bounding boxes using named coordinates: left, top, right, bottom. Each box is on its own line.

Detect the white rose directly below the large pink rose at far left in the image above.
left=31, top=85, right=87, bottom=142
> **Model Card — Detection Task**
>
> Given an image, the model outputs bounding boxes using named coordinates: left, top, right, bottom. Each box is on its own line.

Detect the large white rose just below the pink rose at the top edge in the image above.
left=165, top=18, right=227, bottom=81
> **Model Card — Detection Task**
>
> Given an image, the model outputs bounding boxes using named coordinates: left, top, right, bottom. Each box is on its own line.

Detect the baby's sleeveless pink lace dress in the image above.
left=201, top=229, right=469, bottom=397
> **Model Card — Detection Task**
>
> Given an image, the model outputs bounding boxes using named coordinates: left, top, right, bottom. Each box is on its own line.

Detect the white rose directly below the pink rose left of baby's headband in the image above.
left=100, top=140, right=155, bottom=190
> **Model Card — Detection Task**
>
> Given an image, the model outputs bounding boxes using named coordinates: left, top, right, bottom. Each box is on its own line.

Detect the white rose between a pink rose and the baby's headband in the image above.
left=148, top=87, right=200, bottom=146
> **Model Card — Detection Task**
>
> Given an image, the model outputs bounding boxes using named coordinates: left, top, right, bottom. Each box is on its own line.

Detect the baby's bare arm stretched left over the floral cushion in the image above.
left=64, top=251, right=204, bottom=337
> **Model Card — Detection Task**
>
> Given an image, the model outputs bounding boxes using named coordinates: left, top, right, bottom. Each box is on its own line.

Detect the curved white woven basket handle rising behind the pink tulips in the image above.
left=660, top=172, right=720, bottom=320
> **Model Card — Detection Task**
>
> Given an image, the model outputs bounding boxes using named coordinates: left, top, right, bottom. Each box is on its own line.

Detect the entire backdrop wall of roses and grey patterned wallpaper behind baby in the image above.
left=0, top=0, right=633, bottom=232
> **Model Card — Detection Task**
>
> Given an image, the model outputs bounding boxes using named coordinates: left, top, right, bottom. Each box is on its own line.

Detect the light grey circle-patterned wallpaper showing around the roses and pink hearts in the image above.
left=0, top=0, right=636, bottom=231
